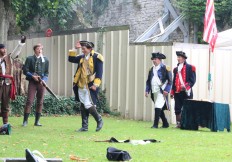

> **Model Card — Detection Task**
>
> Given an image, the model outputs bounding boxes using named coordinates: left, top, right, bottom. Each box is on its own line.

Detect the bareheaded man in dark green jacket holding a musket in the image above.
left=23, top=44, right=49, bottom=126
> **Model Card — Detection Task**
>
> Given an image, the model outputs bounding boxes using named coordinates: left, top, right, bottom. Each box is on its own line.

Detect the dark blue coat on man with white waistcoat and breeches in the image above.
left=146, top=63, right=172, bottom=101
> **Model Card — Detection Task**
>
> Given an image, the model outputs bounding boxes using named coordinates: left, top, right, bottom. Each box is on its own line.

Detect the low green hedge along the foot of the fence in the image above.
left=10, top=90, right=113, bottom=116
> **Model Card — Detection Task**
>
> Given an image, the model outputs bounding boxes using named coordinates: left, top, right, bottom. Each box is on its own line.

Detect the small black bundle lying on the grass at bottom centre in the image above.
left=106, top=147, right=131, bottom=161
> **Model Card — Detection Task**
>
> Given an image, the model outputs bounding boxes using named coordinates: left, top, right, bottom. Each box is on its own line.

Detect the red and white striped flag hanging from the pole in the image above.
left=203, top=0, right=218, bottom=52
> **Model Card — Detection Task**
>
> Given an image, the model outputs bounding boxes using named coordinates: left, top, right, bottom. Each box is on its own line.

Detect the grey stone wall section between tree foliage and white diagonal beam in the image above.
left=93, top=0, right=164, bottom=41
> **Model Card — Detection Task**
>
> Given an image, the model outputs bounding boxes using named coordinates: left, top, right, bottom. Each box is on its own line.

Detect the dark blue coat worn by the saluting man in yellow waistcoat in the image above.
left=68, top=53, right=103, bottom=105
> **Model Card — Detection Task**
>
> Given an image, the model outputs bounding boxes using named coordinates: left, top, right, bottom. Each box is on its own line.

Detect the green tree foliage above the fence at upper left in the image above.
left=11, top=0, right=85, bottom=31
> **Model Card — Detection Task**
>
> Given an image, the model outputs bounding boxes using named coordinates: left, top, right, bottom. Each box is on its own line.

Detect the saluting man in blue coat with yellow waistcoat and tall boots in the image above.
left=68, top=41, right=104, bottom=132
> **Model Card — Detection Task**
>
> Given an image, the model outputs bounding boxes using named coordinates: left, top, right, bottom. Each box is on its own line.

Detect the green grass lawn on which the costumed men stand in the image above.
left=0, top=116, right=232, bottom=162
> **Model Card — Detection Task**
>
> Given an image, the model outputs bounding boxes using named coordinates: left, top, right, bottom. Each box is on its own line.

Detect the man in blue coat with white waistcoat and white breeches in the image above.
left=145, top=52, right=172, bottom=128
